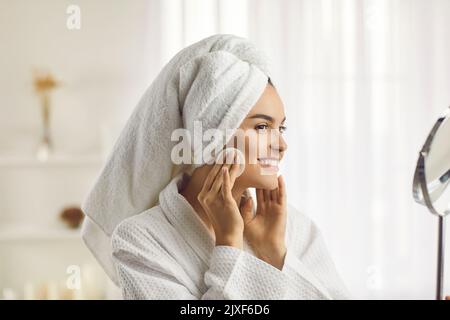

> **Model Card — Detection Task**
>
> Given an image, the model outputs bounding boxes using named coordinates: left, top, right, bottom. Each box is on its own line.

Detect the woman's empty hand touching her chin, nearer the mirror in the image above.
left=241, top=175, right=287, bottom=270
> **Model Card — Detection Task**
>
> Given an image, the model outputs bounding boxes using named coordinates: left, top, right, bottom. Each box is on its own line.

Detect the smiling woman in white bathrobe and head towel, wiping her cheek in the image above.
left=79, top=35, right=348, bottom=299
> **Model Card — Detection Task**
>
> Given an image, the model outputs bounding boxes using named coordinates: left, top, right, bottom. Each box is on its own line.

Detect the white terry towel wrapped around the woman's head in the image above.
left=82, top=34, right=270, bottom=284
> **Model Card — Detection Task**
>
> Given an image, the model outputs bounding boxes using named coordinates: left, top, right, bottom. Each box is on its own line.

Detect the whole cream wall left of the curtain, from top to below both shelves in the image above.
left=0, top=0, right=162, bottom=298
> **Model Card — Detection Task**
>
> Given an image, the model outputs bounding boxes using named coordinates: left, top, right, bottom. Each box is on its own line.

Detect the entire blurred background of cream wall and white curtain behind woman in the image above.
left=0, top=0, right=450, bottom=299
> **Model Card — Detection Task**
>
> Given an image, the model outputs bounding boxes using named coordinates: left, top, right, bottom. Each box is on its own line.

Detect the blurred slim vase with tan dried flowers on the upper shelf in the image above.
left=33, top=71, right=60, bottom=161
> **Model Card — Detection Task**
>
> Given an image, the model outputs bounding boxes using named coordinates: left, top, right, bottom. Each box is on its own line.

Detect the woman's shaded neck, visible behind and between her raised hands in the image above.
left=179, top=165, right=246, bottom=235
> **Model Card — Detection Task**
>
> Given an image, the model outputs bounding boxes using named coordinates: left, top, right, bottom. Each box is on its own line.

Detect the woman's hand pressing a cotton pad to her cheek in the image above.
left=197, top=152, right=244, bottom=249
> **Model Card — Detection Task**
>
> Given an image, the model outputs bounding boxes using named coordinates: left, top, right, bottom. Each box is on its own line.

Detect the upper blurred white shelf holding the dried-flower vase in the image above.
left=0, top=155, right=104, bottom=168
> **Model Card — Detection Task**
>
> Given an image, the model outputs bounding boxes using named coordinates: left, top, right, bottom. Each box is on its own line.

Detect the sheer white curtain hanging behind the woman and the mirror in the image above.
left=143, top=0, right=450, bottom=299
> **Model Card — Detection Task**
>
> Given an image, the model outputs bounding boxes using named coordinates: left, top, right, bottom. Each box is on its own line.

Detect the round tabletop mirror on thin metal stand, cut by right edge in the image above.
left=413, top=107, right=450, bottom=300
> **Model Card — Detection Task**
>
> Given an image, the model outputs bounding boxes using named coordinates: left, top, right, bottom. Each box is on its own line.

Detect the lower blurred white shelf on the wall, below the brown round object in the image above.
left=0, top=224, right=82, bottom=243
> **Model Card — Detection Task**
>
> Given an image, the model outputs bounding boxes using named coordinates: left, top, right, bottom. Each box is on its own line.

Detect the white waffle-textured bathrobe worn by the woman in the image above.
left=111, top=172, right=350, bottom=300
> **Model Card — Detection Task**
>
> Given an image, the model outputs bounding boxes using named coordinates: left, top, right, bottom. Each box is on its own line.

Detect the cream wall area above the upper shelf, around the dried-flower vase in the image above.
left=0, top=0, right=160, bottom=154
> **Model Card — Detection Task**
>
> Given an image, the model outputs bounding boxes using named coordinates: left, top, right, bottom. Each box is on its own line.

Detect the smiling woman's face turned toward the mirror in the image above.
left=229, top=84, right=287, bottom=190
